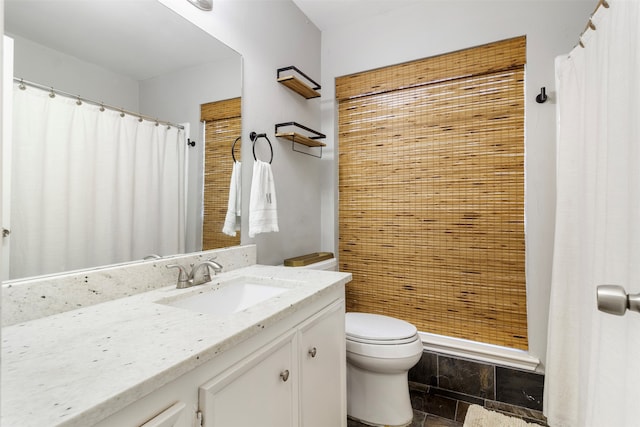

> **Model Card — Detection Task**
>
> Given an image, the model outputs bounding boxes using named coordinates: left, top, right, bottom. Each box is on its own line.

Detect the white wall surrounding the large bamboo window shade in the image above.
left=321, top=0, right=596, bottom=370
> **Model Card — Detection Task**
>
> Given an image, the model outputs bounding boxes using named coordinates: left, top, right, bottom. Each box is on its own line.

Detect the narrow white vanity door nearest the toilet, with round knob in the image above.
left=298, top=300, right=347, bottom=427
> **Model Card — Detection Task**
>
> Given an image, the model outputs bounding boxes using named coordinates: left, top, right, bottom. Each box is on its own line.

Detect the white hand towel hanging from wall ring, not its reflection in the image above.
left=249, top=160, right=280, bottom=237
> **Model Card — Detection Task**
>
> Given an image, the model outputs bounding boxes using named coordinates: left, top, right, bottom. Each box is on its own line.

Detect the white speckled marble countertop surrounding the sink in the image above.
left=1, top=265, right=350, bottom=427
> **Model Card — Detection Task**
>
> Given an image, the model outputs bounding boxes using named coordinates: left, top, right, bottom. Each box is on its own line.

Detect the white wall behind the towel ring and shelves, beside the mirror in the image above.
left=160, top=0, right=326, bottom=264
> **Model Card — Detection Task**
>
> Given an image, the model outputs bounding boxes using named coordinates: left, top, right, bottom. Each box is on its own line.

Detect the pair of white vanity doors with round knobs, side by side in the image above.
left=200, top=299, right=346, bottom=427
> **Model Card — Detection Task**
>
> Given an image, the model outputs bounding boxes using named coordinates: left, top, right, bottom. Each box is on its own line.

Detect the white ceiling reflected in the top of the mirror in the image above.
left=4, top=0, right=237, bottom=80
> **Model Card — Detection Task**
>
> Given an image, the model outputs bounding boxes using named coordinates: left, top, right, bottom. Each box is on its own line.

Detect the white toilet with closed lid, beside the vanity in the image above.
left=345, top=313, right=422, bottom=426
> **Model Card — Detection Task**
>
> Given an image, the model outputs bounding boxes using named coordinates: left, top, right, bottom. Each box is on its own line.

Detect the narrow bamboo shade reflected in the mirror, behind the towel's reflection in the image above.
left=200, top=98, right=242, bottom=250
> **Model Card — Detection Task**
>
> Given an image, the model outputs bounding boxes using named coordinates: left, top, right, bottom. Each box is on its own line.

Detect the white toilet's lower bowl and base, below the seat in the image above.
left=347, top=363, right=413, bottom=427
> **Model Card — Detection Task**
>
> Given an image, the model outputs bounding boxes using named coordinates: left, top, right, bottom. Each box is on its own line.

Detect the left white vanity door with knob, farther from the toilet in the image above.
left=199, top=331, right=298, bottom=427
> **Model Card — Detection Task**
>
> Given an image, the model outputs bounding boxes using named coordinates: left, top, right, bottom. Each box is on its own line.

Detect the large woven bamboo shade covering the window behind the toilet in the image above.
left=336, top=37, right=527, bottom=349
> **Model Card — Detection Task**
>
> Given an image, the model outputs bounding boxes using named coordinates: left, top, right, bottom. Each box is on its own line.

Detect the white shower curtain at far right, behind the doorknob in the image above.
left=544, top=0, right=640, bottom=427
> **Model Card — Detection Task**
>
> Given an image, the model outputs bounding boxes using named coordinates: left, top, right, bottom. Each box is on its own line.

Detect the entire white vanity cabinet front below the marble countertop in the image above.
left=95, top=287, right=347, bottom=427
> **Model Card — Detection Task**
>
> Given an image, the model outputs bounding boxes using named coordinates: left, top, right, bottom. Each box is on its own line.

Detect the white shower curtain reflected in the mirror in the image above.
left=10, top=86, right=186, bottom=277
